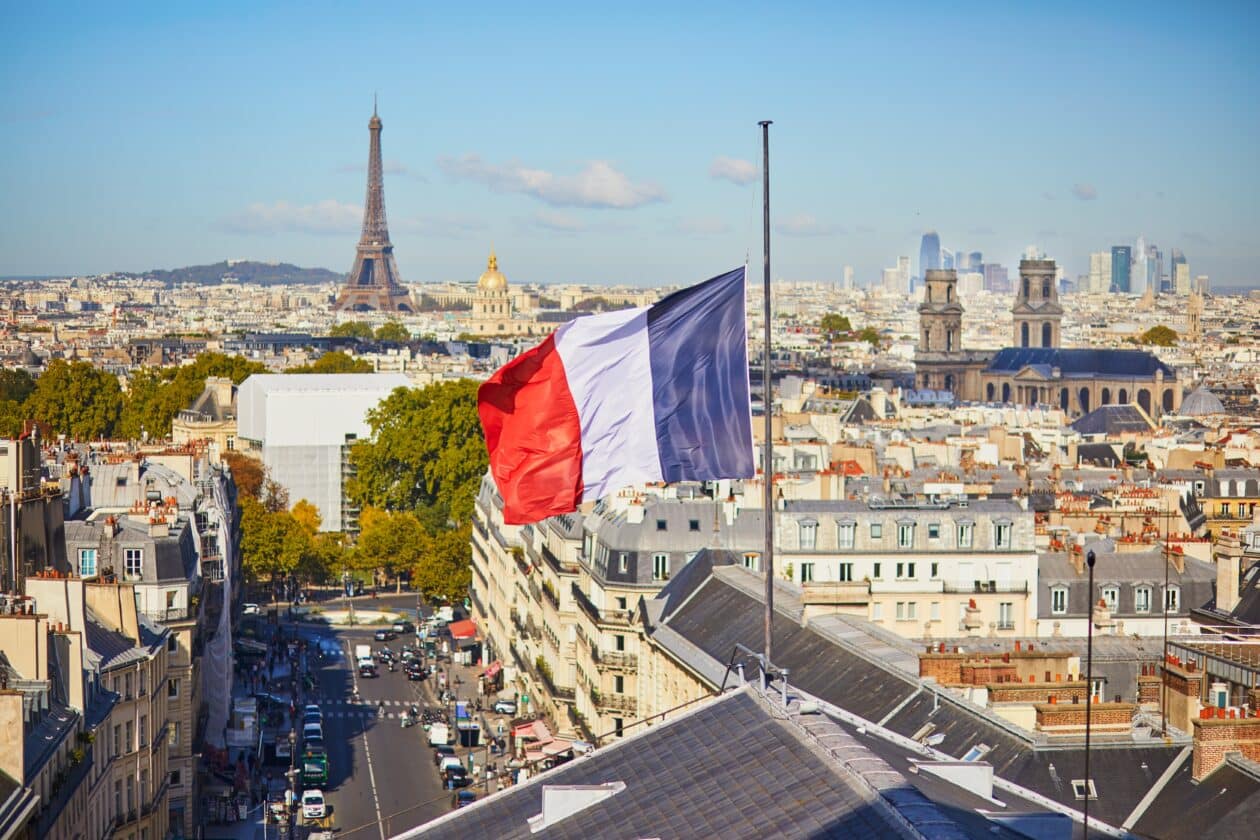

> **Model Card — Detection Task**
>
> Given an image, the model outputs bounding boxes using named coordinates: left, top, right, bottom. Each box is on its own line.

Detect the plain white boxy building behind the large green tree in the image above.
left=237, top=373, right=411, bottom=531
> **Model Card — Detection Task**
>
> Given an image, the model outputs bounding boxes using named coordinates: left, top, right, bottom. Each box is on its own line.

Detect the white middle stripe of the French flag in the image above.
left=556, top=307, right=662, bottom=501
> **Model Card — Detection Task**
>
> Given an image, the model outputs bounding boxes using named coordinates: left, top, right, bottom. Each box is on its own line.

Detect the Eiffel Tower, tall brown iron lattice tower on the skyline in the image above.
left=333, top=102, right=416, bottom=312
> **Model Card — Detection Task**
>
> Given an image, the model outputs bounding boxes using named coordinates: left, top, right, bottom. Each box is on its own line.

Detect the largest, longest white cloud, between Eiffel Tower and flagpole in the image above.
left=437, top=155, right=668, bottom=210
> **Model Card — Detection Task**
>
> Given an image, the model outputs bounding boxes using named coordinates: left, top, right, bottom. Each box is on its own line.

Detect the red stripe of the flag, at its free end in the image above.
left=476, top=336, right=582, bottom=525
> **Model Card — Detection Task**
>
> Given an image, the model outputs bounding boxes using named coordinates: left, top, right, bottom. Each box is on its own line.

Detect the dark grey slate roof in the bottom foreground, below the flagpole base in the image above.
left=401, top=689, right=966, bottom=840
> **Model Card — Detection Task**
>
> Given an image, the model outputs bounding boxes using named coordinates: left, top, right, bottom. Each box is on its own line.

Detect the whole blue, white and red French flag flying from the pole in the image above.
left=478, top=268, right=752, bottom=525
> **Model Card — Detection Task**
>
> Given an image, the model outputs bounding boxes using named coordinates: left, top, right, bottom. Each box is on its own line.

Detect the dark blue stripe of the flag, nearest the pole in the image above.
left=645, top=268, right=752, bottom=481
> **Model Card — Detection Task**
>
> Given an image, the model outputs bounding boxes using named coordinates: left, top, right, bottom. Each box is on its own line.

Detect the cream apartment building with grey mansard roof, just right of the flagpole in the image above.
left=776, top=496, right=1037, bottom=639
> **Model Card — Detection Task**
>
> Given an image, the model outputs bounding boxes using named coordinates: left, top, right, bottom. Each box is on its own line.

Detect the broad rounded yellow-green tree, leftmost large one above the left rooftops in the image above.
left=24, top=359, right=122, bottom=440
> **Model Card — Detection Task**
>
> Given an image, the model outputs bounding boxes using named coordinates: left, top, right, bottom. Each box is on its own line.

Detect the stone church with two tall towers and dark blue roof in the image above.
left=915, top=259, right=1182, bottom=419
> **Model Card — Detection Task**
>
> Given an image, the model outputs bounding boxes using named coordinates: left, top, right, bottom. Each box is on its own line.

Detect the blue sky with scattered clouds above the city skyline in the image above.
left=0, top=1, right=1260, bottom=285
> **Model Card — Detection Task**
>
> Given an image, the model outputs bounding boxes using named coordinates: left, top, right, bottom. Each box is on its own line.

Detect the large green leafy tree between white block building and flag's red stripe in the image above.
left=347, top=379, right=489, bottom=523
